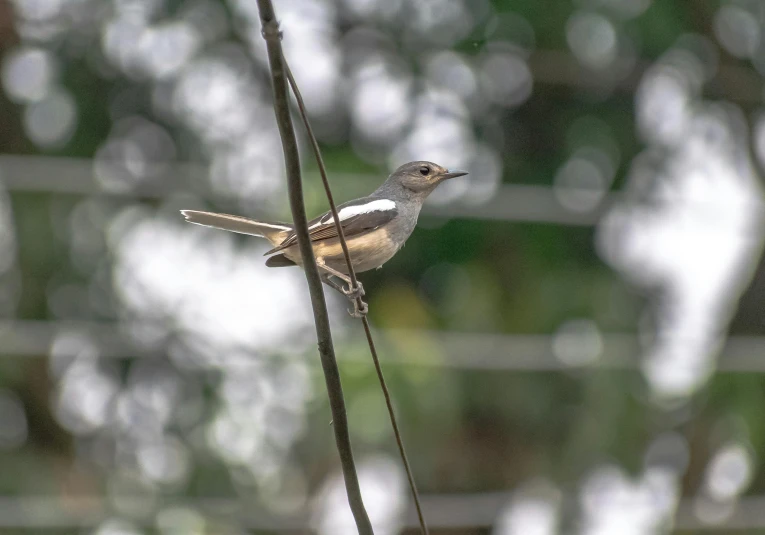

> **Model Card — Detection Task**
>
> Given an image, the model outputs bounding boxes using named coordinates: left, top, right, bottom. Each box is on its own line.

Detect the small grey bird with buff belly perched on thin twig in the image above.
left=181, top=161, right=468, bottom=317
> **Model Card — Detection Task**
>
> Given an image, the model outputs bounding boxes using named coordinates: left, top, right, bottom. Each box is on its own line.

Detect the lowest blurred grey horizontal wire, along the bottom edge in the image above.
left=0, top=491, right=765, bottom=533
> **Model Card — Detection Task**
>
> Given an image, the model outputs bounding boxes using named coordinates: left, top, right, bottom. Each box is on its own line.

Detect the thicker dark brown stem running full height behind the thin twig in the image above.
left=257, top=0, right=374, bottom=535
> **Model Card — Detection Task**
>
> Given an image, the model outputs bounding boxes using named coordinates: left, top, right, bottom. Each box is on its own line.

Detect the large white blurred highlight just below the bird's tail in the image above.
left=112, top=212, right=312, bottom=358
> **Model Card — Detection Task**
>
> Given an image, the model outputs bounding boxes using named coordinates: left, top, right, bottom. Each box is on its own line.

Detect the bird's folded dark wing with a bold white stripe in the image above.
left=266, top=197, right=398, bottom=255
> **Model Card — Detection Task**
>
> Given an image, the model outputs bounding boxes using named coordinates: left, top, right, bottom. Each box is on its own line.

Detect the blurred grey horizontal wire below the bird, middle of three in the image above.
left=0, top=320, right=765, bottom=373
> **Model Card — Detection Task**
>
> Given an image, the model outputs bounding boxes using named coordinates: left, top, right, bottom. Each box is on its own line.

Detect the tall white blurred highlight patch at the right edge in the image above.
left=598, top=48, right=765, bottom=398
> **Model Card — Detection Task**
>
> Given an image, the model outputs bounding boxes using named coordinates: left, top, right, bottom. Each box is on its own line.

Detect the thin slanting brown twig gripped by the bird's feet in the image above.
left=284, top=58, right=428, bottom=535
